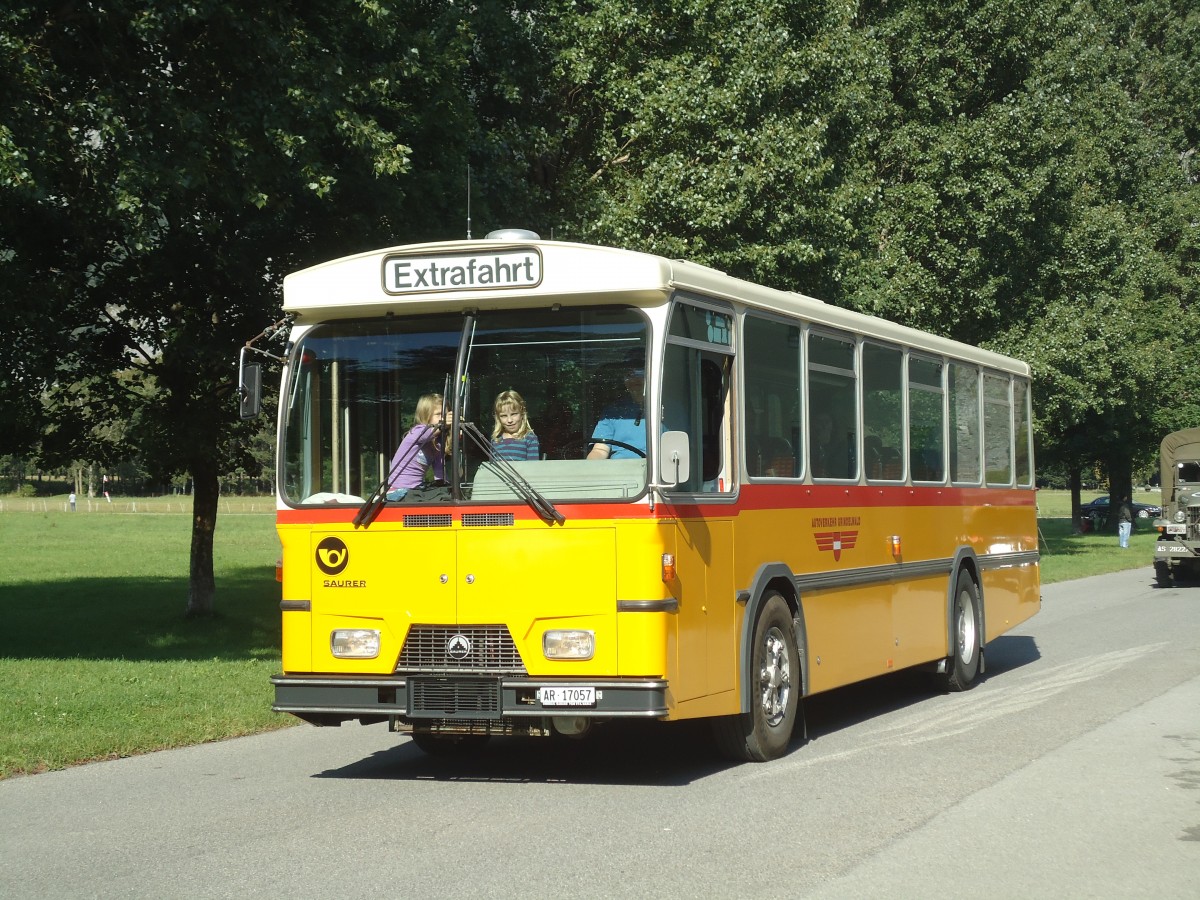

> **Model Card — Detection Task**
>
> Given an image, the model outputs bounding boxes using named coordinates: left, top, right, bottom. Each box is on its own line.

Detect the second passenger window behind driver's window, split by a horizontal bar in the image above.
left=809, top=331, right=858, bottom=480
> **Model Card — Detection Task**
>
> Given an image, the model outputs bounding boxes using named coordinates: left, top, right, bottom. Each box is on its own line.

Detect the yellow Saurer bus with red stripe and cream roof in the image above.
left=255, top=229, right=1040, bottom=761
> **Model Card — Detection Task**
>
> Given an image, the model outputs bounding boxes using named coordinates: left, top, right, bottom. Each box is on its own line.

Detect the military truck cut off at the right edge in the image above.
left=1154, top=428, right=1200, bottom=587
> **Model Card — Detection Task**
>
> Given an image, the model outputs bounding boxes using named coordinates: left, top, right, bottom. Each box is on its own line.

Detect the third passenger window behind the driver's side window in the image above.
left=863, top=342, right=904, bottom=481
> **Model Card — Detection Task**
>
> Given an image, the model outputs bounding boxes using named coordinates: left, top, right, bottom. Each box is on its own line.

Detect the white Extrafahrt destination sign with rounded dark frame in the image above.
left=383, top=248, right=541, bottom=294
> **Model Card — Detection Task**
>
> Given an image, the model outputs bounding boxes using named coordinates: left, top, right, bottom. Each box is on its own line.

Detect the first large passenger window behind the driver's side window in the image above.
left=742, top=316, right=803, bottom=478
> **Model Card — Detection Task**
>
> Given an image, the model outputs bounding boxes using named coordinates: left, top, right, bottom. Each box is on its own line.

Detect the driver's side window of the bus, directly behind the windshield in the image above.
left=662, top=302, right=733, bottom=492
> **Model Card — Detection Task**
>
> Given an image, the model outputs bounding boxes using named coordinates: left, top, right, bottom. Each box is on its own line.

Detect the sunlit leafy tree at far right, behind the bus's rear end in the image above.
left=845, top=2, right=1198, bottom=520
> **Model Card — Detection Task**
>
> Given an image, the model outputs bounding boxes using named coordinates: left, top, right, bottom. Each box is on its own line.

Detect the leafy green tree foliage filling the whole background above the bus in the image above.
left=0, top=0, right=1200, bottom=576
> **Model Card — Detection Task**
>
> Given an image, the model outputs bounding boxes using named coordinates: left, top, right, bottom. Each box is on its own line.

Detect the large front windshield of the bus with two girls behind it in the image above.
left=281, top=306, right=648, bottom=505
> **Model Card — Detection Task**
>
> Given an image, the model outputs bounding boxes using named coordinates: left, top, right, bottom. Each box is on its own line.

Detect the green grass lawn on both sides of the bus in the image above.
left=0, top=491, right=1157, bottom=778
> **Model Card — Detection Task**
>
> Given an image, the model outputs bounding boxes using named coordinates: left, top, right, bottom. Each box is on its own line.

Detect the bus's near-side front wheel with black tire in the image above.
left=713, top=593, right=804, bottom=762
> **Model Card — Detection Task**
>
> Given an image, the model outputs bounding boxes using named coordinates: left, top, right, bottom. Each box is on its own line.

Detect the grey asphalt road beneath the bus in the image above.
left=0, top=568, right=1200, bottom=900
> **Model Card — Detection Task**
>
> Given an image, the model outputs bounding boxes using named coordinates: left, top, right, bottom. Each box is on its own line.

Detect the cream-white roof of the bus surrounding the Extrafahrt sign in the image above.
left=283, top=239, right=1030, bottom=377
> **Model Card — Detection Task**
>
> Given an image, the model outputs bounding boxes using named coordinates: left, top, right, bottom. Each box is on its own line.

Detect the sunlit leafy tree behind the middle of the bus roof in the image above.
left=535, top=0, right=881, bottom=296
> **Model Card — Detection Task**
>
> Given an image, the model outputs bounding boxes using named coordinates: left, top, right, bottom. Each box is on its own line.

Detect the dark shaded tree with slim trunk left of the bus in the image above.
left=0, top=0, right=506, bottom=614
